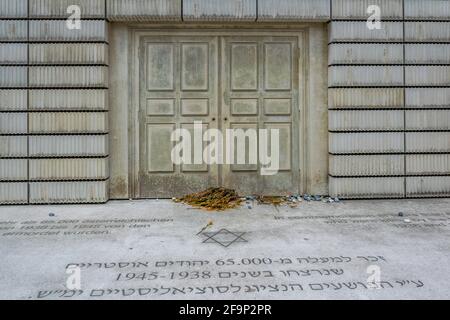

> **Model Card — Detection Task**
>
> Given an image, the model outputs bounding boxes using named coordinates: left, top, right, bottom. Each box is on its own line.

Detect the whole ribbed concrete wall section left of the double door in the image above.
left=0, top=0, right=109, bottom=204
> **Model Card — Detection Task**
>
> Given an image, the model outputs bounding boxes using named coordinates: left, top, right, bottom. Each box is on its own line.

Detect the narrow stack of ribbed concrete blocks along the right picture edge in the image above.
left=405, top=13, right=450, bottom=197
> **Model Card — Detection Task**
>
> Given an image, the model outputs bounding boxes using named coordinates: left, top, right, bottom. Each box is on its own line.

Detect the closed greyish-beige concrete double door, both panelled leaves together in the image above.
left=138, top=36, right=300, bottom=198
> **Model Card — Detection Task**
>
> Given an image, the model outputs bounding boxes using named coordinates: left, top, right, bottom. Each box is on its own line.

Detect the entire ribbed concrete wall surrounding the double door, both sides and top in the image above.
left=0, top=0, right=450, bottom=204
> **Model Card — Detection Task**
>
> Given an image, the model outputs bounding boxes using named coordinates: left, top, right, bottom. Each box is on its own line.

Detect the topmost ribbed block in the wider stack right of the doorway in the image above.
left=331, top=0, right=403, bottom=20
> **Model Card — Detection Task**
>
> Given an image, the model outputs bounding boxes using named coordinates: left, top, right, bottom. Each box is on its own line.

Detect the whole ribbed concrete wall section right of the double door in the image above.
left=328, top=0, right=450, bottom=198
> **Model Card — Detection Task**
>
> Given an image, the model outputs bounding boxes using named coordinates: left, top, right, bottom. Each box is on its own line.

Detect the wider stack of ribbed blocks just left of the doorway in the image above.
left=21, top=0, right=108, bottom=203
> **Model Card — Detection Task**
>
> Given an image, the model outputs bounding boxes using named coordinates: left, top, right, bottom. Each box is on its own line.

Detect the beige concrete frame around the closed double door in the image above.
left=128, top=24, right=309, bottom=199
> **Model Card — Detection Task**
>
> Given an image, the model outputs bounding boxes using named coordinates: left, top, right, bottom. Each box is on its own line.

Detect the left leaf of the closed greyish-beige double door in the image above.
left=139, top=36, right=219, bottom=198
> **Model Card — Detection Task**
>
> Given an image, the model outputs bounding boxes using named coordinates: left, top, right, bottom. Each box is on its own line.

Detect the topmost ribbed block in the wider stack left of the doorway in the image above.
left=29, top=0, right=106, bottom=19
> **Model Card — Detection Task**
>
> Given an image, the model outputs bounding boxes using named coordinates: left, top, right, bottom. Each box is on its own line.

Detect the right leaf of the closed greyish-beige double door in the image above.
left=221, top=37, right=300, bottom=195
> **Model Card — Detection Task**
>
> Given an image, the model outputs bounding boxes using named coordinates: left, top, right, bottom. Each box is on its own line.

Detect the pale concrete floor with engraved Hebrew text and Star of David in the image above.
left=0, top=199, right=450, bottom=299
